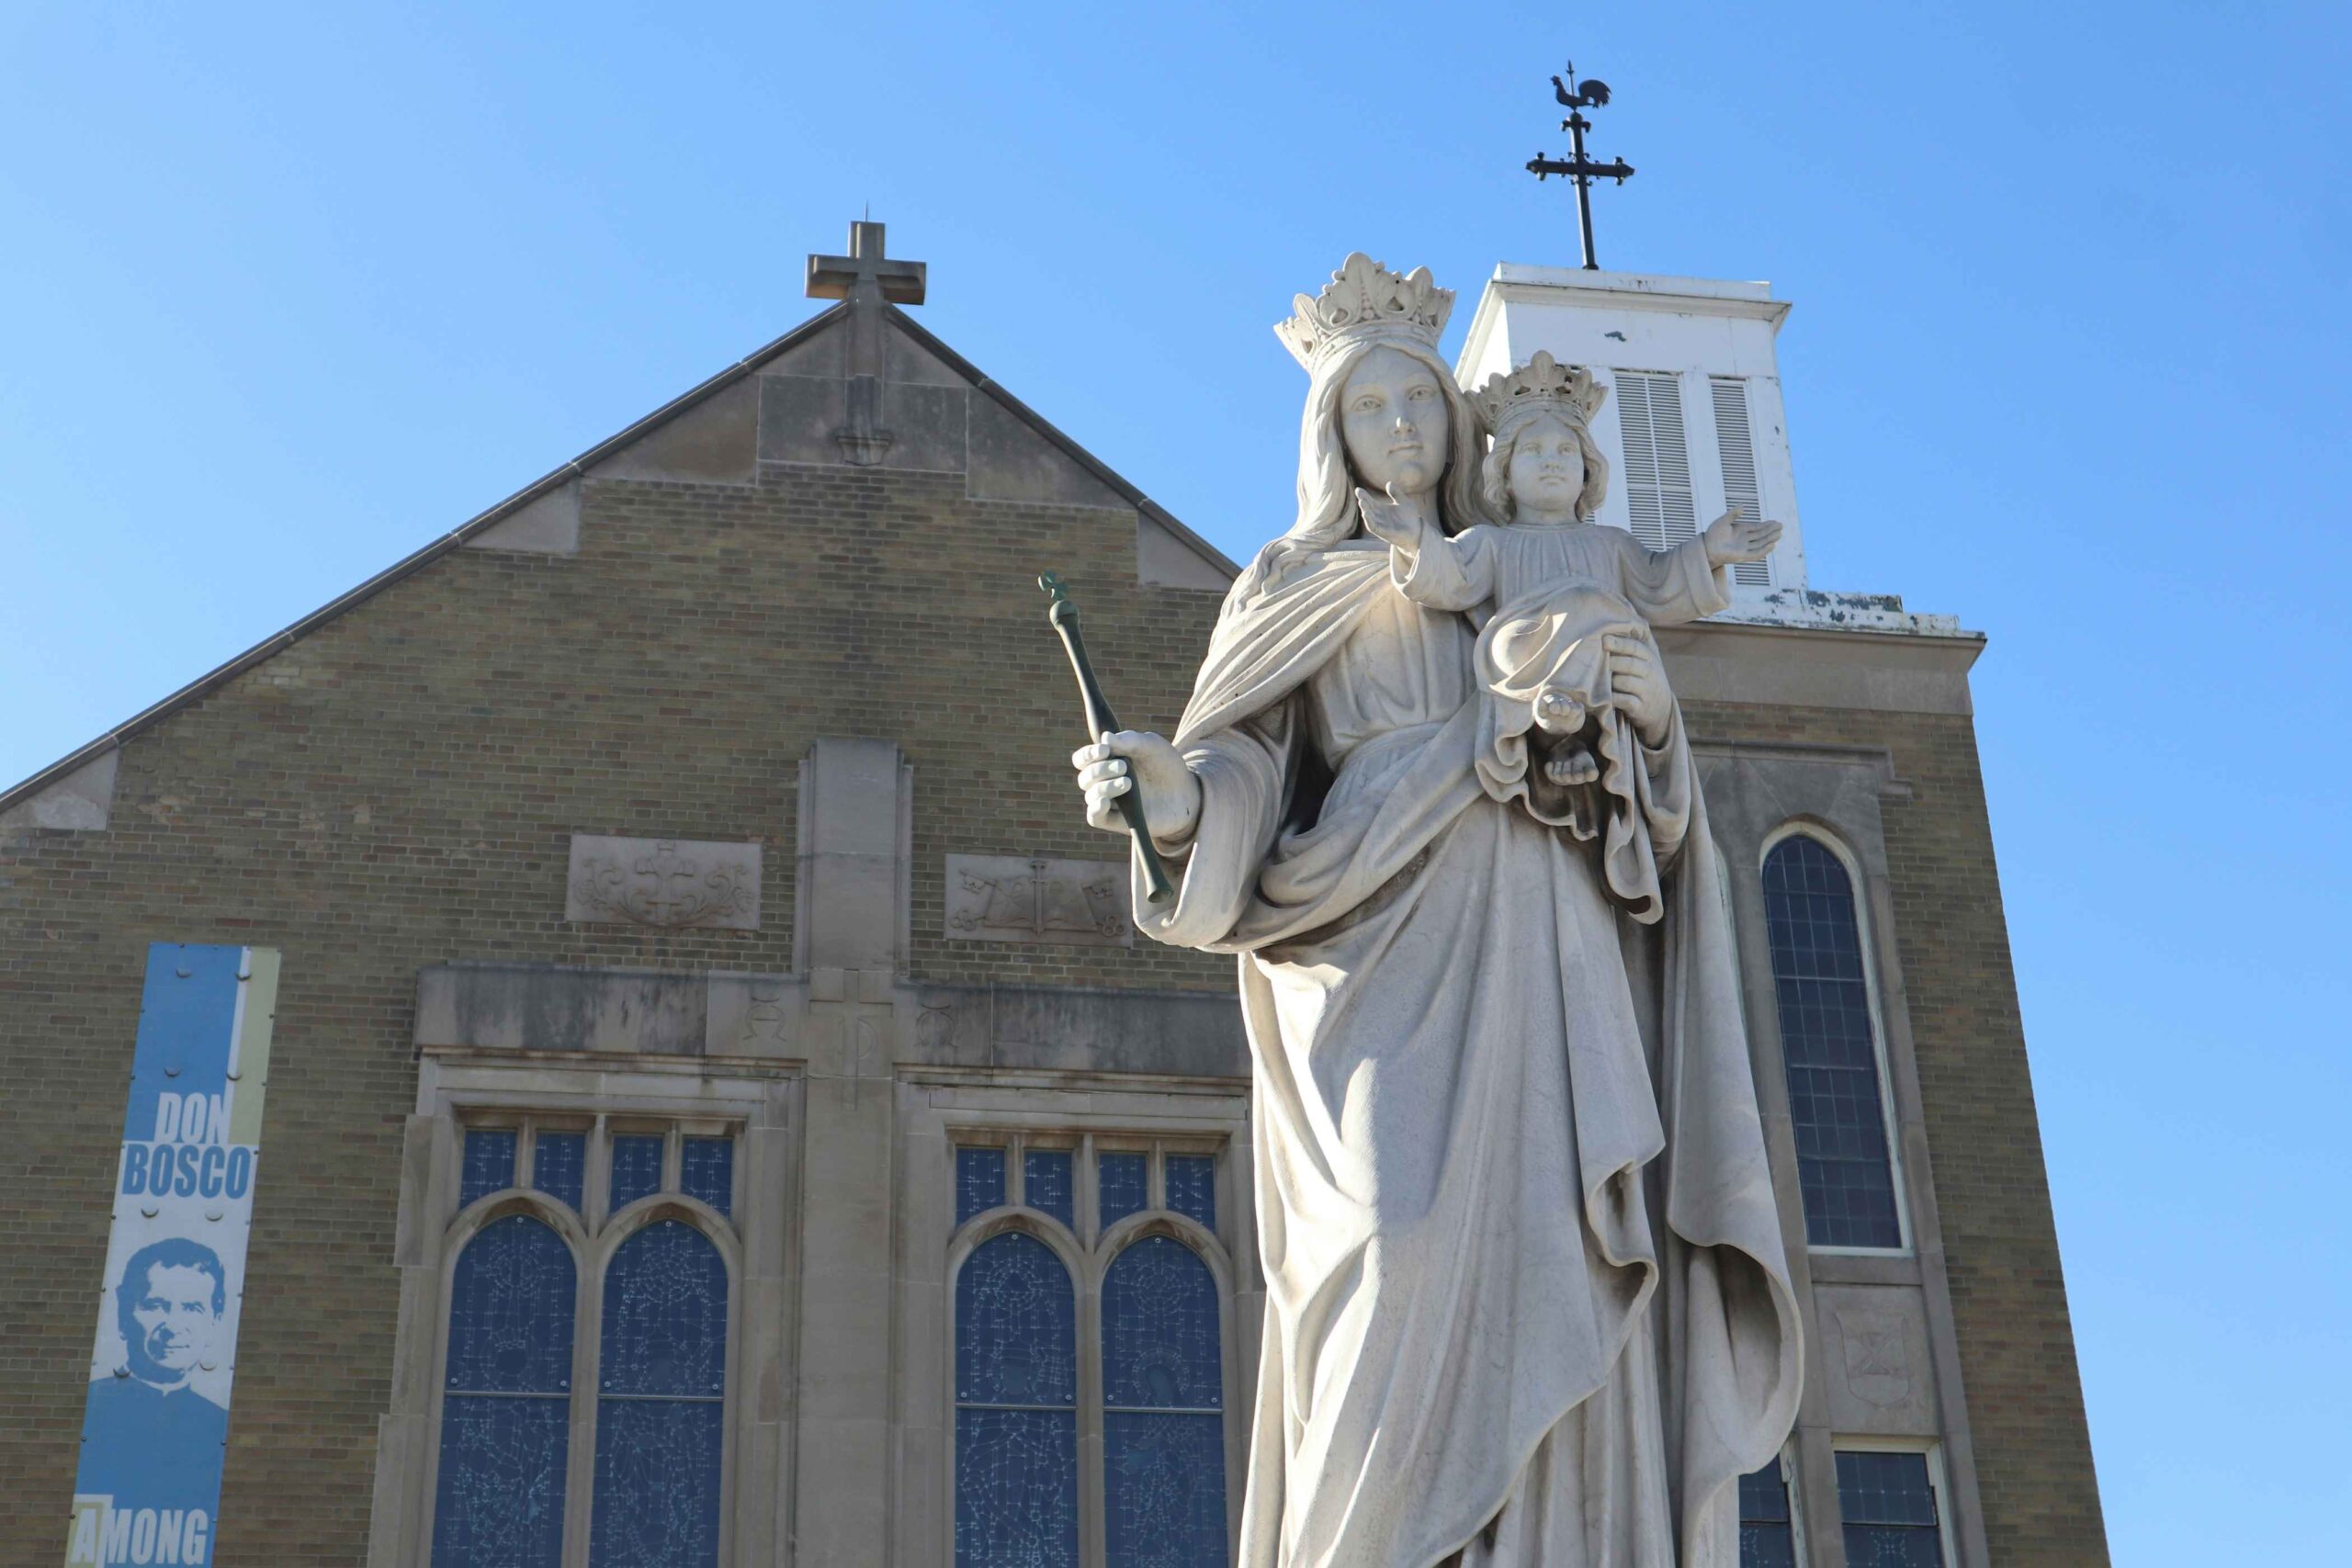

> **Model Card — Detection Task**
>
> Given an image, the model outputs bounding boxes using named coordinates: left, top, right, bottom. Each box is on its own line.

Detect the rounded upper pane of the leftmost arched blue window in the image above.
left=442, top=1213, right=576, bottom=1404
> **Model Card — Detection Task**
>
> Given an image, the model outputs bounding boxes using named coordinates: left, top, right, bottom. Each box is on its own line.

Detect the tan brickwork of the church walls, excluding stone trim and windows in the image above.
left=0, top=288, right=2105, bottom=1565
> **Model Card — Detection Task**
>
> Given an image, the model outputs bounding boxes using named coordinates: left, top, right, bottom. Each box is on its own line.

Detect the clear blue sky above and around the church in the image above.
left=0, top=0, right=2352, bottom=1563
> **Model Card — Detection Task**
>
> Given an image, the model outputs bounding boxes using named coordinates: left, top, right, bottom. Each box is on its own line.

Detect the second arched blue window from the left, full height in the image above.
left=585, top=1220, right=727, bottom=1568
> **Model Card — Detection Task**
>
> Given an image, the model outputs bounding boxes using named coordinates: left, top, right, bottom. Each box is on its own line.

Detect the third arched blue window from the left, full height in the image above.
left=955, top=1232, right=1077, bottom=1568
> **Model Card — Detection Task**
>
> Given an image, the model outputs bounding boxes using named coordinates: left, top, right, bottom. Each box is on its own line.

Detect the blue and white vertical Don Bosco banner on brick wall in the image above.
left=66, top=942, right=277, bottom=1568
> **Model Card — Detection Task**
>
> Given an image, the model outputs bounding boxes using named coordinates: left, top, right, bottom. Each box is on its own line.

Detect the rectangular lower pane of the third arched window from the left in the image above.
left=955, top=1410, right=1077, bottom=1568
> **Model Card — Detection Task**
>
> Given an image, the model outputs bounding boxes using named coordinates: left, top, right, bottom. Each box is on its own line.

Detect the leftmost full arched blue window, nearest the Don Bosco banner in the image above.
left=433, top=1213, right=579, bottom=1568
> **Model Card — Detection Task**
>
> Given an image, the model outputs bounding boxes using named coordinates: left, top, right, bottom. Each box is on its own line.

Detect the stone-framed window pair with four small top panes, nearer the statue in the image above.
left=950, top=1134, right=1232, bottom=1568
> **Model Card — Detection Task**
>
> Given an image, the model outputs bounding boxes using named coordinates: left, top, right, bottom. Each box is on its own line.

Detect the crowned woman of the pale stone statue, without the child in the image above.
left=1075, top=254, right=1799, bottom=1568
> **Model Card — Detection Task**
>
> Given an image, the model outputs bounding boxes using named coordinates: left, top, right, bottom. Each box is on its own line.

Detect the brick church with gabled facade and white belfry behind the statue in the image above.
left=0, top=223, right=2108, bottom=1568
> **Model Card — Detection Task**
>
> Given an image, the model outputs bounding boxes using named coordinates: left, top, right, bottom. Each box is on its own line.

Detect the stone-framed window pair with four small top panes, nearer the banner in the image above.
left=430, top=1117, right=741, bottom=1568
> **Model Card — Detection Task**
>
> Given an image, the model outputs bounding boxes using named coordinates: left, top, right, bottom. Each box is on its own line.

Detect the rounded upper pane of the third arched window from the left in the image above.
left=955, top=1232, right=1077, bottom=1405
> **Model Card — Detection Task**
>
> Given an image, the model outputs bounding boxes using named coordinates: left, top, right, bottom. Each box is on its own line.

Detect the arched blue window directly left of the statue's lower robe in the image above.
left=1103, top=1236, right=1226, bottom=1568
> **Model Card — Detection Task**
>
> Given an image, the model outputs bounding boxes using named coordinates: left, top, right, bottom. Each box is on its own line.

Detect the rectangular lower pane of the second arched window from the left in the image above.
left=588, top=1399, right=727, bottom=1568
